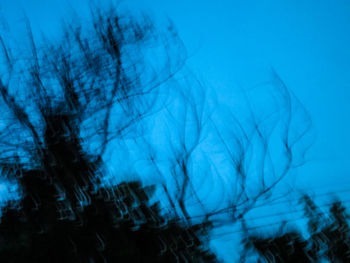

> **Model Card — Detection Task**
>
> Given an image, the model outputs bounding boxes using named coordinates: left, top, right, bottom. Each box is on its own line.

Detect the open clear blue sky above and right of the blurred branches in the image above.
left=0, top=0, right=350, bottom=262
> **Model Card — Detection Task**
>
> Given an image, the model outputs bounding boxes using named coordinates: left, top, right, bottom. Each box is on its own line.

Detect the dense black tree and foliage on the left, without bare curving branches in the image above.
left=0, top=6, right=215, bottom=263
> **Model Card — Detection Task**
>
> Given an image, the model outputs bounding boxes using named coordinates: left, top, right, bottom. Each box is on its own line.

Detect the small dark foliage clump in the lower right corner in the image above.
left=246, top=196, right=350, bottom=262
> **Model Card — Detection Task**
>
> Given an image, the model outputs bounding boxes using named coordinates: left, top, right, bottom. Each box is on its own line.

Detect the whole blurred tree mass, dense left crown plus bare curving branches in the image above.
left=0, top=3, right=310, bottom=262
